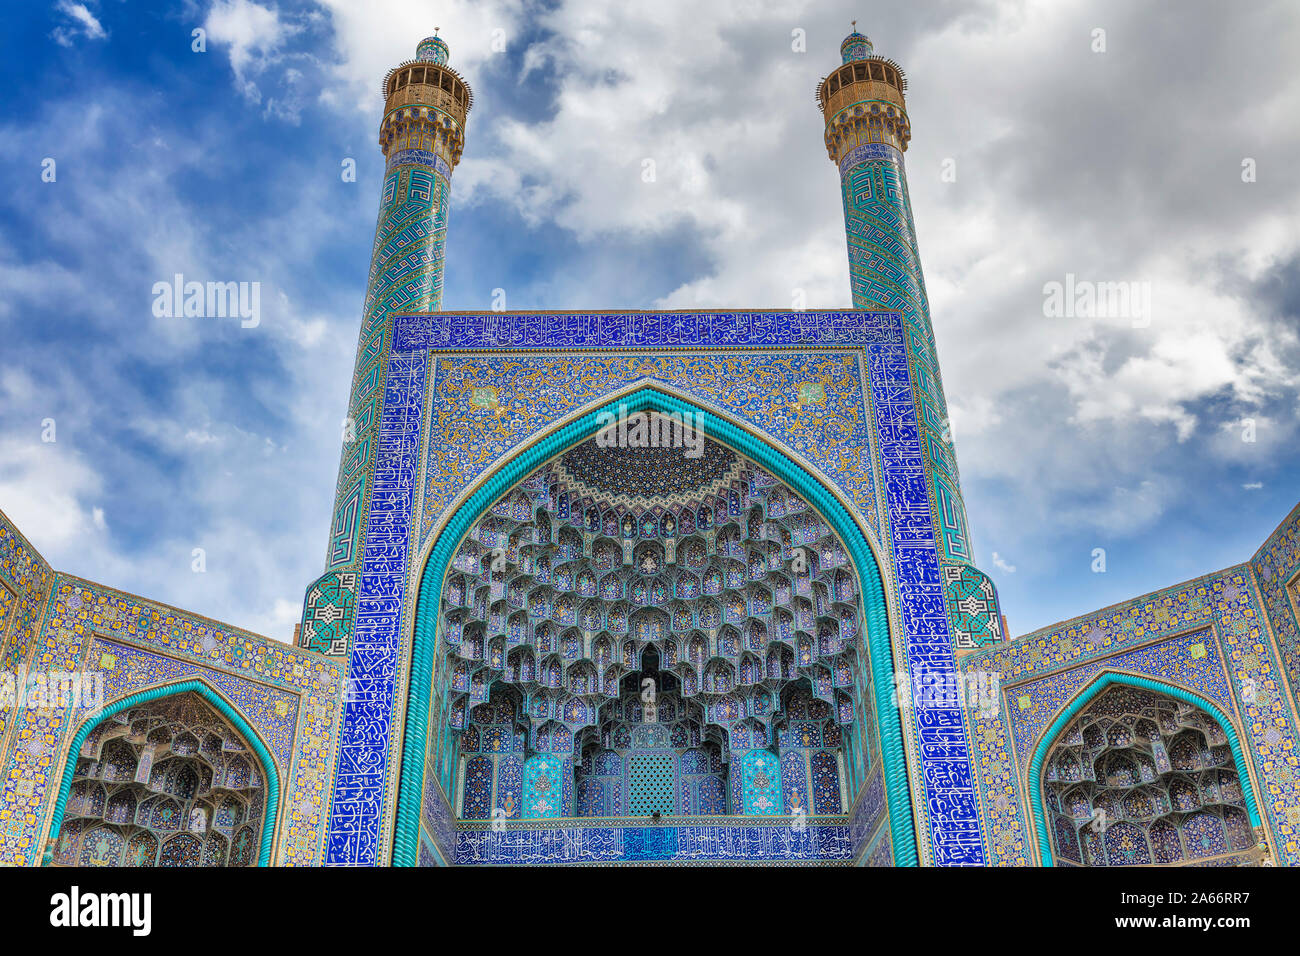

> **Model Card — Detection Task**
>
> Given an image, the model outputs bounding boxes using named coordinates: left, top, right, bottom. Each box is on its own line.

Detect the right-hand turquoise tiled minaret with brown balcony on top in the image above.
left=816, top=30, right=971, bottom=595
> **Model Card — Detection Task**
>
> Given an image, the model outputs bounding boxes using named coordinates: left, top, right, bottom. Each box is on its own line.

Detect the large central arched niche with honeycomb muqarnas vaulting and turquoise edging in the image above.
left=394, top=389, right=915, bottom=865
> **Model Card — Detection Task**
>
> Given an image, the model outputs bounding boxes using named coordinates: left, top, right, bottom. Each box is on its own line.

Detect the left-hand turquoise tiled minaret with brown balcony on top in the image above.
left=298, top=36, right=473, bottom=654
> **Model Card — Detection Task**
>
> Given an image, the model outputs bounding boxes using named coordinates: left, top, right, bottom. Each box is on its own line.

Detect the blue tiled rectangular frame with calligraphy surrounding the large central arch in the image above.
left=326, top=311, right=984, bottom=865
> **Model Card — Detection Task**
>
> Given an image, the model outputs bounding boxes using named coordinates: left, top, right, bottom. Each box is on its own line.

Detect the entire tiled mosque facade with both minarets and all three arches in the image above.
left=0, top=33, right=1300, bottom=866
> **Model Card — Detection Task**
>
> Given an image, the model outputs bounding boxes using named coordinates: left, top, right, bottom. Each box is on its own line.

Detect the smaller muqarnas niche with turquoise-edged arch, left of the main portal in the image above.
left=47, top=682, right=280, bottom=866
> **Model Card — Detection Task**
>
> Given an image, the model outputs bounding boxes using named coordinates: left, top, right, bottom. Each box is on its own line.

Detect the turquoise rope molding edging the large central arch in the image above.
left=393, top=386, right=918, bottom=866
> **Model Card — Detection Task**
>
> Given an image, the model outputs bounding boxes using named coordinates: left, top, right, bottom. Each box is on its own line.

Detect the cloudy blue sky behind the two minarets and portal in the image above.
left=0, top=0, right=1300, bottom=640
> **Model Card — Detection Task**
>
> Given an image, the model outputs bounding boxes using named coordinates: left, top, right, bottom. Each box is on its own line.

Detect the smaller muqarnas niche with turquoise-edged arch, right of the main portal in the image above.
left=1030, top=674, right=1265, bottom=866
